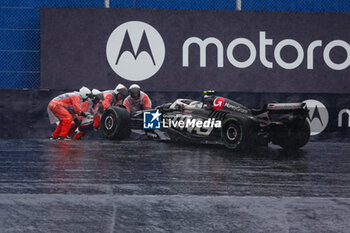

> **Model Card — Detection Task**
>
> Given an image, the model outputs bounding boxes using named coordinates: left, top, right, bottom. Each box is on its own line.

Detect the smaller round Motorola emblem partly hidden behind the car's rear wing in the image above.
left=303, top=100, right=329, bottom=136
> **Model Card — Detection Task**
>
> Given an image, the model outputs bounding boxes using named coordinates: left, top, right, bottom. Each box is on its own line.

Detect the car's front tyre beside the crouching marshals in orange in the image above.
left=101, top=106, right=130, bottom=140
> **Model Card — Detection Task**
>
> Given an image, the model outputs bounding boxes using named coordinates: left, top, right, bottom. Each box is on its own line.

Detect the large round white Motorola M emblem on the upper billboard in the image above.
left=106, top=21, right=165, bottom=81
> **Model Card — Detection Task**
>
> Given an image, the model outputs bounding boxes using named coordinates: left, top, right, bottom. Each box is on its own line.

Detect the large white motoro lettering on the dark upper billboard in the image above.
left=182, top=31, right=350, bottom=70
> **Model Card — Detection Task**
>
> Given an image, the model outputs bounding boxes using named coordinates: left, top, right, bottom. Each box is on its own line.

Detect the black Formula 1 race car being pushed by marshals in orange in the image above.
left=101, top=92, right=310, bottom=149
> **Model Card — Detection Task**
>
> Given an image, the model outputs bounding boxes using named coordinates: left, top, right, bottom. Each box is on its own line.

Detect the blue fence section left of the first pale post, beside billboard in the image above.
left=0, top=0, right=105, bottom=88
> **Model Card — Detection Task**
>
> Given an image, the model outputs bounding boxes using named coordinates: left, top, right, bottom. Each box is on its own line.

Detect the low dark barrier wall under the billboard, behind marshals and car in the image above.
left=0, top=89, right=350, bottom=142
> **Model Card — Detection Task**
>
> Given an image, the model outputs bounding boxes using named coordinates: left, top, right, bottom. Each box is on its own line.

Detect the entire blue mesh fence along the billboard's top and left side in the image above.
left=0, top=0, right=350, bottom=88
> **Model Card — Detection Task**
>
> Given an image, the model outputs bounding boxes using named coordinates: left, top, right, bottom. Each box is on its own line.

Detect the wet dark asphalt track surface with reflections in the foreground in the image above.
left=0, top=139, right=350, bottom=233
